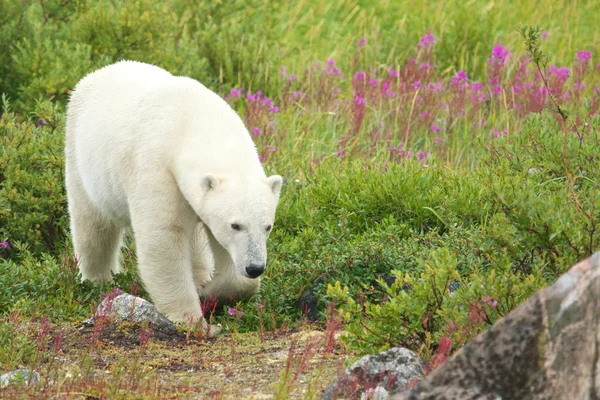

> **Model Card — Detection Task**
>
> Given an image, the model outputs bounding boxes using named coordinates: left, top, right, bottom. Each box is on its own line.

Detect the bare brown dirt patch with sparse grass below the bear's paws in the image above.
left=0, top=323, right=346, bottom=399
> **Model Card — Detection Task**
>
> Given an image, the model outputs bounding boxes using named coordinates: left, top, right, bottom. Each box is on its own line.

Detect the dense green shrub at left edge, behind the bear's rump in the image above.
left=0, top=98, right=67, bottom=254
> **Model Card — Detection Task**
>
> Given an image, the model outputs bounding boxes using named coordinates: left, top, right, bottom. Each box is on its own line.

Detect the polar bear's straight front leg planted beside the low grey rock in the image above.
left=131, top=193, right=204, bottom=324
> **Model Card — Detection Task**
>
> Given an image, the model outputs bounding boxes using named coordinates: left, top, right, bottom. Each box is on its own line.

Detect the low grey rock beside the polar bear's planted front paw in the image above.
left=94, top=293, right=177, bottom=330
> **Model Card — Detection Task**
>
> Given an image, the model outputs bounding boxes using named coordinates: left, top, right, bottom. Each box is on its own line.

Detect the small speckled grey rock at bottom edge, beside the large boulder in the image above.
left=322, top=347, right=425, bottom=400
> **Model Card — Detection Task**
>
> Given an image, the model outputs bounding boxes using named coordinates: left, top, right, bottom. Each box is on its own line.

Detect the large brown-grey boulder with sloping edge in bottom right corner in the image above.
left=393, top=253, right=600, bottom=400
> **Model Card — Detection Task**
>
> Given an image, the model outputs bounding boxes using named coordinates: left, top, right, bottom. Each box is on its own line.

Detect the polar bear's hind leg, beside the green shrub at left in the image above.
left=67, top=174, right=122, bottom=282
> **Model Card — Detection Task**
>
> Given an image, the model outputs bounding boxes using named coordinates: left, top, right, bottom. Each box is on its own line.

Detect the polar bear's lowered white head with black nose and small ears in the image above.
left=194, top=174, right=283, bottom=279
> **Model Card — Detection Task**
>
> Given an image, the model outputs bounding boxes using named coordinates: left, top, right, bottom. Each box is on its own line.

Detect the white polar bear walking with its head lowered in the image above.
left=65, top=61, right=282, bottom=324
